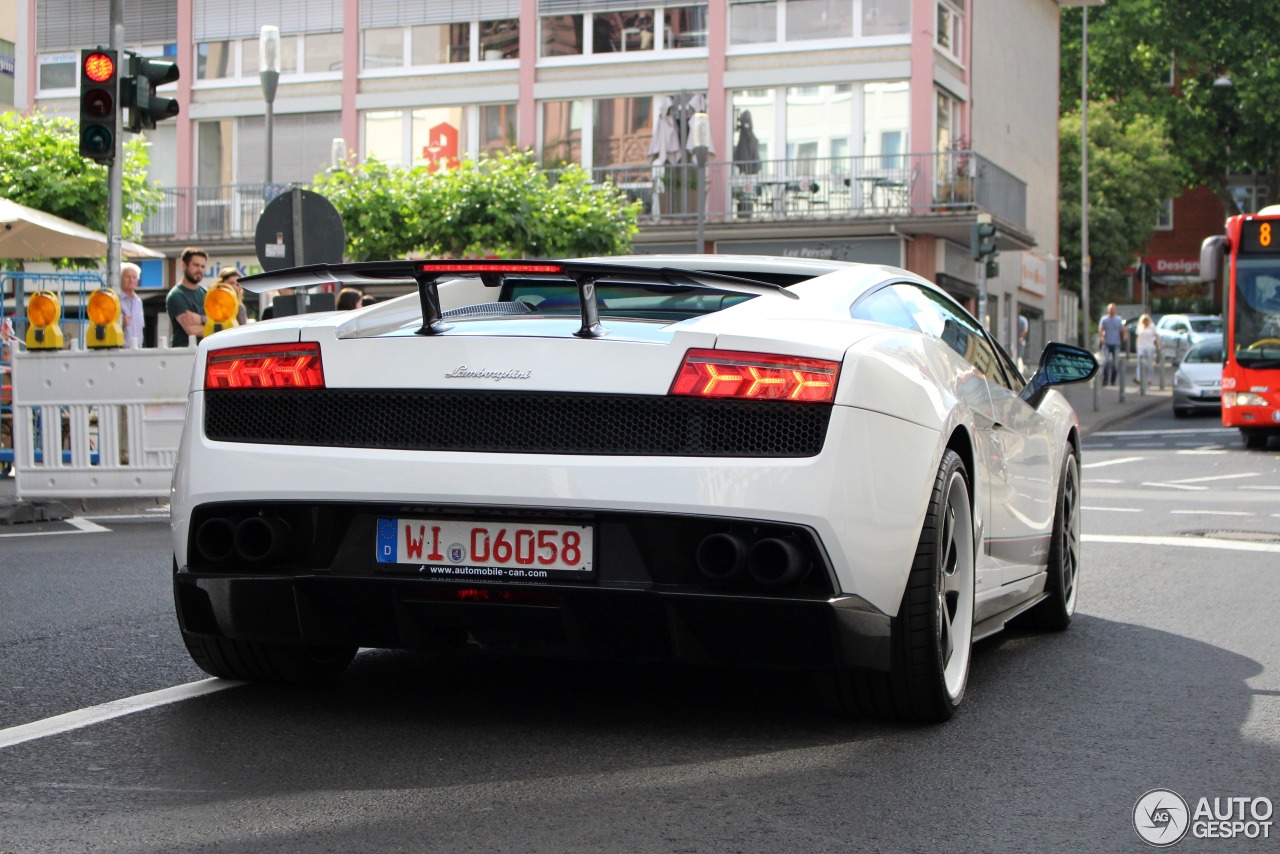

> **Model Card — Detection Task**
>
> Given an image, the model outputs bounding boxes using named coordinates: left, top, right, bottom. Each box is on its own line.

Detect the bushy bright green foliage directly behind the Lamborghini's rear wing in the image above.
left=312, top=151, right=640, bottom=261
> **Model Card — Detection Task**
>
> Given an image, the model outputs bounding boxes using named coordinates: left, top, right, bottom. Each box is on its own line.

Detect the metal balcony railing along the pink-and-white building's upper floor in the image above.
left=135, top=150, right=1027, bottom=243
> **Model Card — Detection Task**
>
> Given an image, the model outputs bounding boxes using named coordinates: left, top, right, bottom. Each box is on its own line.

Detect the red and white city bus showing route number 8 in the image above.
left=1201, top=205, right=1280, bottom=448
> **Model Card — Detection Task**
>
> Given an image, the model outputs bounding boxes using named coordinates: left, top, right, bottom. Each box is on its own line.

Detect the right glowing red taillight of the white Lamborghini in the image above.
left=671, top=350, right=840, bottom=403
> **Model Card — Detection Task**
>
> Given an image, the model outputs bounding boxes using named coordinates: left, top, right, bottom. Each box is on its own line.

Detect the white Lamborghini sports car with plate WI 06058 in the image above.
left=172, top=256, right=1097, bottom=721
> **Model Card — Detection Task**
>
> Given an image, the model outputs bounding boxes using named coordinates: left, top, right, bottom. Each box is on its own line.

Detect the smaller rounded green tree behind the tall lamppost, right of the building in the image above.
left=1057, top=99, right=1181, bottom=310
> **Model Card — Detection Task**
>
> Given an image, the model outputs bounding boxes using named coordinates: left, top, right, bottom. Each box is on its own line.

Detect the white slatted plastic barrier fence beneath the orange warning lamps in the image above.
left=13, top=348, right=196, bottom=498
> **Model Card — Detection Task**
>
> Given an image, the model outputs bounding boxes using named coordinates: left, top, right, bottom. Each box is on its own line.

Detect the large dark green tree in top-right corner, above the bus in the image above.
left=1061, top=0, right=1280, bottom=209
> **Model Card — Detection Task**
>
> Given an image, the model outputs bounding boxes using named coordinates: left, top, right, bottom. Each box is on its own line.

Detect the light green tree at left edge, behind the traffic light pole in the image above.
left=0, top=113, right=160, bottom=266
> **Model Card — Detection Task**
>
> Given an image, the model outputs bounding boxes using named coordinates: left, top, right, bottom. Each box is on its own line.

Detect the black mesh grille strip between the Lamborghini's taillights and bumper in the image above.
left=205, top=389, right=831, bottom=457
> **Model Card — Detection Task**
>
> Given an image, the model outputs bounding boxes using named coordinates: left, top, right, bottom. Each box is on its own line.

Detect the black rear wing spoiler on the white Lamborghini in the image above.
left=239, top=260, right=800, bottom=338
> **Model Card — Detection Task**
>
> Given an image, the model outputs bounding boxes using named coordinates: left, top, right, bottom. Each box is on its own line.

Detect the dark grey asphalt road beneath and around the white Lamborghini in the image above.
left=0, top=412, right=1280, bottom=854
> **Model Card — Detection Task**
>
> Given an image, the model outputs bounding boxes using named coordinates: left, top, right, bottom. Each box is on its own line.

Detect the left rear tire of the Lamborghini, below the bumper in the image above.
left=182, top=631, right=356, bottom=685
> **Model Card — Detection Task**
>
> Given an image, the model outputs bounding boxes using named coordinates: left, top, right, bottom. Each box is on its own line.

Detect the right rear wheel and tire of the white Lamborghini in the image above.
left=845, top=449, right=975, bottom=723
